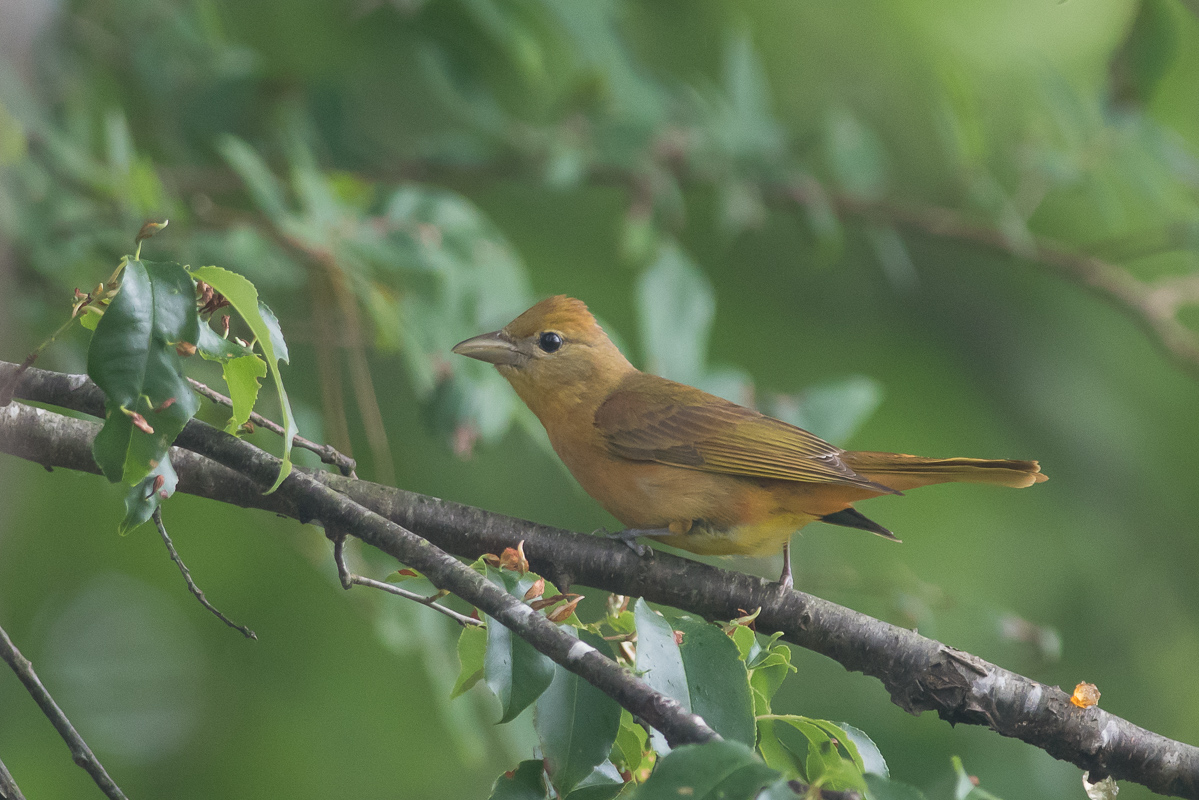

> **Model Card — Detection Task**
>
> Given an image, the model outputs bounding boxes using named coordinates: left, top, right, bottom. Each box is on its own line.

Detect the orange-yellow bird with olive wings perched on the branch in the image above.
left=453, top=295, right=1048, bottom=589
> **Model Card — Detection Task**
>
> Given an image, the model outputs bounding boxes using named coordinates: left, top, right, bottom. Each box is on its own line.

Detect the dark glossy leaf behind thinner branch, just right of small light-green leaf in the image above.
left=483, top=567, right=554, bottom=722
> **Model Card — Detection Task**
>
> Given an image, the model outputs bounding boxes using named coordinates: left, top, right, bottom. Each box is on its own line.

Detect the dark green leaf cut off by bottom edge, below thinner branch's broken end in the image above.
left=632, top=740, right=779, bottom=800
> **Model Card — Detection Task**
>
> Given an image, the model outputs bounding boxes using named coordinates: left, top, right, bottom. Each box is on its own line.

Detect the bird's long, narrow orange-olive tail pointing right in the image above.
left=842, top=451, right=1049, bottom=492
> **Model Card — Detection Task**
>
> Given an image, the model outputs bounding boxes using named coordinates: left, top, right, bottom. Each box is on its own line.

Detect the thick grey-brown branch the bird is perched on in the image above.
left=7, top=362, right=1199, bottom=799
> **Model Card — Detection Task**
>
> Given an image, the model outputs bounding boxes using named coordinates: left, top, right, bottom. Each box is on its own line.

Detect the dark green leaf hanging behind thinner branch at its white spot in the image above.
left=534, top=625, right=620, bottom=795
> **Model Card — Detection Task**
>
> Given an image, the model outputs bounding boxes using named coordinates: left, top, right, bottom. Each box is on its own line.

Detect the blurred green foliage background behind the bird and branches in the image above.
left=0, top=0, right=1199, bottom=798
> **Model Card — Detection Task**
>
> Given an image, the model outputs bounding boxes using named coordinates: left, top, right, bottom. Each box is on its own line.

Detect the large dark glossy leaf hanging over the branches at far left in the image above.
left=88, top=260, right=199, bottom=486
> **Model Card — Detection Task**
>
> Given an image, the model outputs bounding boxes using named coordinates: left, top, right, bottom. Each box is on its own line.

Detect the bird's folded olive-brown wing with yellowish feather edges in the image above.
left=595, top=373, right=892, bottom=493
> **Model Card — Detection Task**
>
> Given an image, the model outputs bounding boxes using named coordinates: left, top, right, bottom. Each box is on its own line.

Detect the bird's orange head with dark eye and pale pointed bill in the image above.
left=453, top=295, right=634, bottom=416
